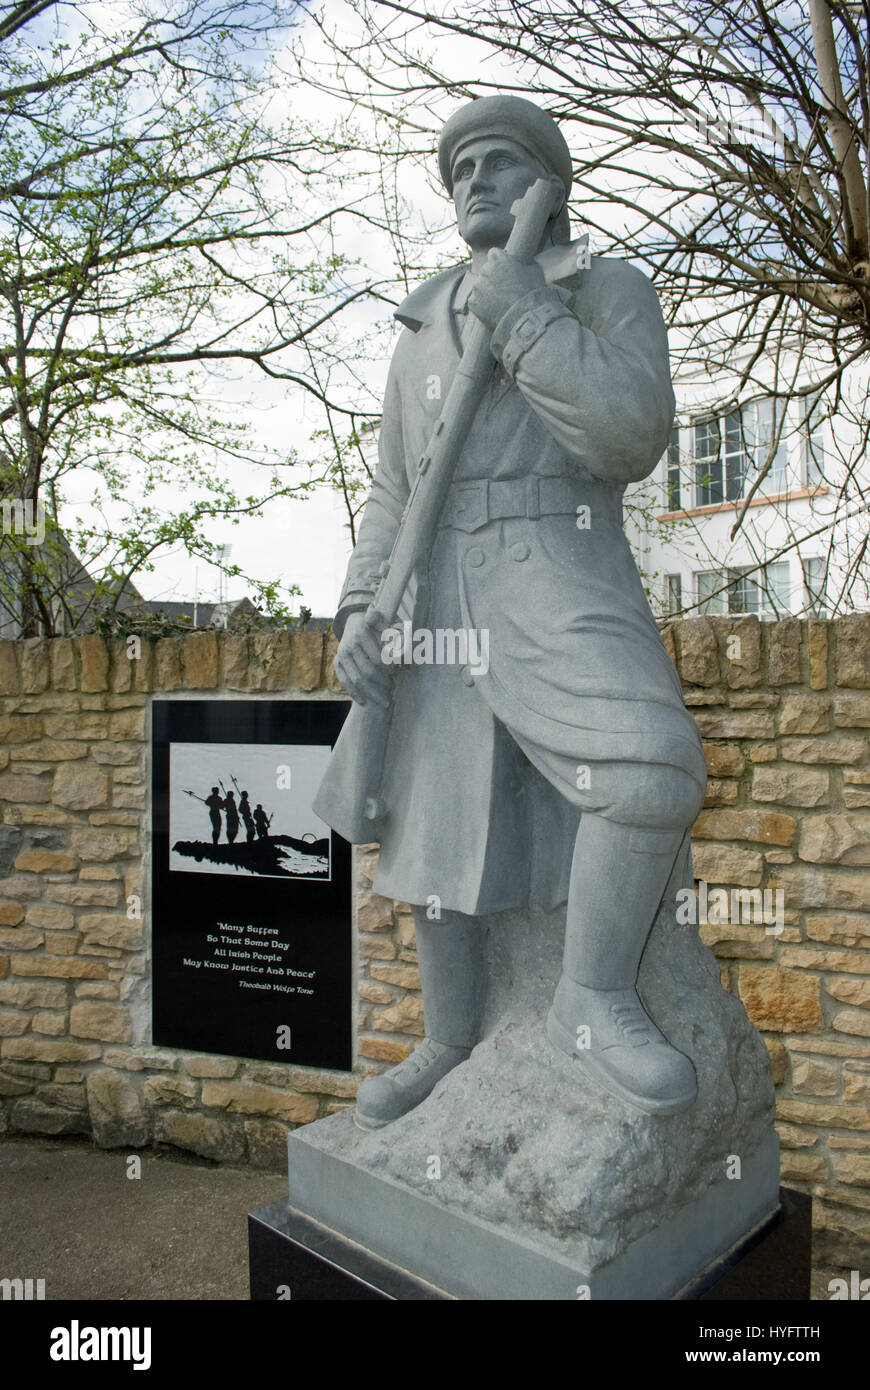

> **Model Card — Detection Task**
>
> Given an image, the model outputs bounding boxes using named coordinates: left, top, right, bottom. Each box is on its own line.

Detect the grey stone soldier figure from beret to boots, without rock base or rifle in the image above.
left=315, top=96, right=706, bottom=1129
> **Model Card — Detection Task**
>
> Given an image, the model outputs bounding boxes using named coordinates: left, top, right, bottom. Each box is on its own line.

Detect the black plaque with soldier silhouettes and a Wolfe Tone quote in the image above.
left=151, top=699, right=352, bottom=1070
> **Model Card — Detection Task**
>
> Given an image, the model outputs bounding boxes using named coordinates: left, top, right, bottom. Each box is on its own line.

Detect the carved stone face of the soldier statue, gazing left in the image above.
left=452, top=136, right=546, bottom=250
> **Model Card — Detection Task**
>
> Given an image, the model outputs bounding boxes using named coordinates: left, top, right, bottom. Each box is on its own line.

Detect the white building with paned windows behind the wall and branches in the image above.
left=625, top=355, right=870, bottom=619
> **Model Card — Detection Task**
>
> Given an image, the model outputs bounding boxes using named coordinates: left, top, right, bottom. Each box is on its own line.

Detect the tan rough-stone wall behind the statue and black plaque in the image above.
left=0, top=614, right=870, bottom=1273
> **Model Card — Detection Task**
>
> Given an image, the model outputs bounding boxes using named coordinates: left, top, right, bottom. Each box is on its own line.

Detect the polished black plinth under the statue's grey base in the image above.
left=247, top=1187, right=812, bottom=1302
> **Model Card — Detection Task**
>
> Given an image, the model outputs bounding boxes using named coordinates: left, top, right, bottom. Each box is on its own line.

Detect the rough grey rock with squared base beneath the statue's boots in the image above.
left=289, top=834, right=778, bottom=1300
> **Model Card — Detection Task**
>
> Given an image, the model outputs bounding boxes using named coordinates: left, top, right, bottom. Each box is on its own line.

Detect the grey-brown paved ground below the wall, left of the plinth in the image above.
left=0, top=1138, right=280, bottom=1300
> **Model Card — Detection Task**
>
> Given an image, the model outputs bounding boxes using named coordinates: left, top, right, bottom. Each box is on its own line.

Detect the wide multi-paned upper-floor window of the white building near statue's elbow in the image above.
left=693, top=396, right=788, bottom=507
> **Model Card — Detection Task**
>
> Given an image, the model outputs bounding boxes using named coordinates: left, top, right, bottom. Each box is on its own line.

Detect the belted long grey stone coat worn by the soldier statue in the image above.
left=315, top=247, right=706, bottom=913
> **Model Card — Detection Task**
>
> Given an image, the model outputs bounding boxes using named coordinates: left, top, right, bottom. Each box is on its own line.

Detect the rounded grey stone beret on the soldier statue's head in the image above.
left=438, top=95, right=574, bottom=242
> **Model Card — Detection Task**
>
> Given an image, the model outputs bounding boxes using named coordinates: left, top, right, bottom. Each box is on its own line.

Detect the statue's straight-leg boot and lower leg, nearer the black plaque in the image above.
left=353, top=908, right=484, bottom=1129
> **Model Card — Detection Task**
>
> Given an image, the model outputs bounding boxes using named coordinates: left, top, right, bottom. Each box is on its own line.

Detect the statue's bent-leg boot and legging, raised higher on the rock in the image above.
left=546, top=815, right=698, bottom=1115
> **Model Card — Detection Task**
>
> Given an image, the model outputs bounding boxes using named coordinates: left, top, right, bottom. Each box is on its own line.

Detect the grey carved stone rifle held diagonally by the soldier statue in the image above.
left=313, top=179, right=555, bottom=844
